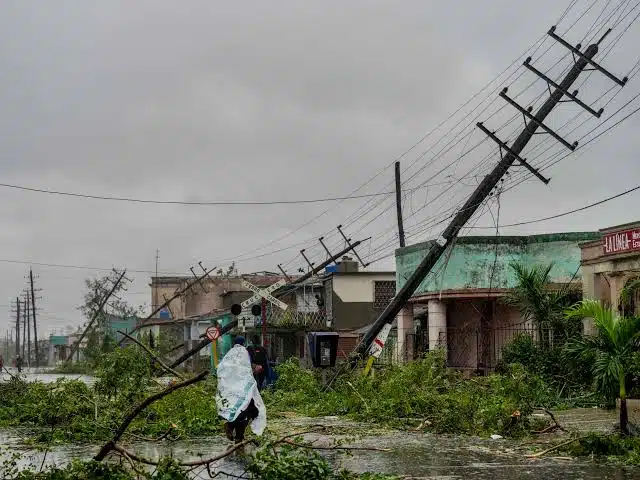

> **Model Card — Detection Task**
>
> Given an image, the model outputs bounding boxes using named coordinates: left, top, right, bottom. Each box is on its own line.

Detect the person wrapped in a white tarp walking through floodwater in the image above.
left=216, top=337, right=267, bottom=443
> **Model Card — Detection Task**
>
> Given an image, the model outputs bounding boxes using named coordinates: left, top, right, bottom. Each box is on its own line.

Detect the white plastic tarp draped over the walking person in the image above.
left=216, top=345, right=267, bottom=435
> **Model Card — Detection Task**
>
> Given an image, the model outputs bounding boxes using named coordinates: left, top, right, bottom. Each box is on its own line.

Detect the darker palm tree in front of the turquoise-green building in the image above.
left=503, top=262, right=573, bottom=348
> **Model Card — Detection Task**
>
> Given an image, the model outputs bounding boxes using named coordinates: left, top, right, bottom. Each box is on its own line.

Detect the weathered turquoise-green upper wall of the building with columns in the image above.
left=396, top=232, right=600, bottom=295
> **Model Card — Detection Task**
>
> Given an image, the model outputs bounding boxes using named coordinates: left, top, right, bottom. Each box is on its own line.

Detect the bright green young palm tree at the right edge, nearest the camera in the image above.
left=566, top=300, right=640, bottom=434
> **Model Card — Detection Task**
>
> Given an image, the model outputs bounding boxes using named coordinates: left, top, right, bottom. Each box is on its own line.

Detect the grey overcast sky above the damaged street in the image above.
left=0, top=0, right=640, bottom=335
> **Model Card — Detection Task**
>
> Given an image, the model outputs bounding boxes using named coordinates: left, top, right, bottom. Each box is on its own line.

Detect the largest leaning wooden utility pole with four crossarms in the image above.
left=355, top=27, right=627, bottom=356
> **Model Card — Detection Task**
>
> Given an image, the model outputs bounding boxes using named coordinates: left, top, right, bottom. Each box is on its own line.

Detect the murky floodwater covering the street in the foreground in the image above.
left=0, top=417, right=640, bottom=480
